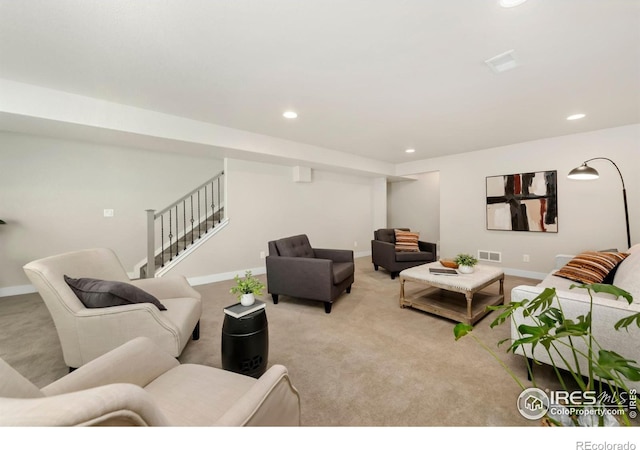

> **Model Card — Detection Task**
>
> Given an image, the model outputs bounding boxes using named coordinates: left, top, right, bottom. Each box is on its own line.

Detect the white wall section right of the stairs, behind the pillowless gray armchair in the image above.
left=162, top=159, right=375, bottom=278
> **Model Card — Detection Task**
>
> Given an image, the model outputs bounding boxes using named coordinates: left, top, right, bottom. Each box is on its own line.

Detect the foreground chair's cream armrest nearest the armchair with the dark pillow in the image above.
left=42, top=337, right=180, bottom=396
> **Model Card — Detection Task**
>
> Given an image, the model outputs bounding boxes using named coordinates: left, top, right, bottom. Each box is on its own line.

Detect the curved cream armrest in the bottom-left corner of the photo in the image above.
left=0, top=384, right=170, bottom=427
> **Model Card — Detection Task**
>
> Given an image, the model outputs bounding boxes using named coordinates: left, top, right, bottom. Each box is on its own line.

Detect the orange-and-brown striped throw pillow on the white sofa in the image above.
left=554, top=252, right=629, bottom=284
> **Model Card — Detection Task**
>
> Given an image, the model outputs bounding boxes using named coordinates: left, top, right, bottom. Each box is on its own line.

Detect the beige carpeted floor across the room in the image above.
left=0, top=257, right=564, bottom=427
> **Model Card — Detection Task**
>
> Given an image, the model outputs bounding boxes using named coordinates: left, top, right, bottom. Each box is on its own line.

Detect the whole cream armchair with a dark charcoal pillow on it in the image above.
left=24, top=248, right=202, bottom=368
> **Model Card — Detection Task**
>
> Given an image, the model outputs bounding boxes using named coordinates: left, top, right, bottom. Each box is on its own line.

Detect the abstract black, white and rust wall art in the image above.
left=487, top=170, right=558, bottom=233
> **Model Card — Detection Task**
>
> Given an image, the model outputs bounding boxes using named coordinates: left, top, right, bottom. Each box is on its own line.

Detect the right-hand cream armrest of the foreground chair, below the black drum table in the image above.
left=215, top=364, right=300, bottom=427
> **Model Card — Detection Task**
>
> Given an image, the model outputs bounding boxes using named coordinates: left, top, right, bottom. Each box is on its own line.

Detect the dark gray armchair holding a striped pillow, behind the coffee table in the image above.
left=371, top=228, right=436, bottom=280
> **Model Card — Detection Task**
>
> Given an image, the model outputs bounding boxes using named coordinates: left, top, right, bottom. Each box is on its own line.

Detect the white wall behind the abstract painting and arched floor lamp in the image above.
left=398, top=125, right=640, bottom=275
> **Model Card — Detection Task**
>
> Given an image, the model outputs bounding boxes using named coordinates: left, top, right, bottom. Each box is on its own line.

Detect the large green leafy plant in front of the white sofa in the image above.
left=454, top=284, right=640, bottom=425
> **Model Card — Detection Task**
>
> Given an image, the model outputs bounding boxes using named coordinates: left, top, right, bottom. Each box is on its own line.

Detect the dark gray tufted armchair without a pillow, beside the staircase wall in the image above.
left=267, top=234, right=355, bottom=314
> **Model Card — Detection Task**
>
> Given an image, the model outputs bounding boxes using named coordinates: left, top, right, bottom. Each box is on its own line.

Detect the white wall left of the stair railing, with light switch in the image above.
left=0, top=132, right=223, bottom=295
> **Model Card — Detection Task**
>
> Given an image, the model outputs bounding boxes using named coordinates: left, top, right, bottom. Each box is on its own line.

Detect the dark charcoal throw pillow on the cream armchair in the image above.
left=64, top=275, right=167, bottom=311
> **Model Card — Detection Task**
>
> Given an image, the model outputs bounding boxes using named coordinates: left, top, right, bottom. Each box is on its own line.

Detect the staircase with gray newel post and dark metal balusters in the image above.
left=140, top=172, right=227, bottom=278
